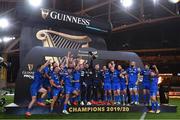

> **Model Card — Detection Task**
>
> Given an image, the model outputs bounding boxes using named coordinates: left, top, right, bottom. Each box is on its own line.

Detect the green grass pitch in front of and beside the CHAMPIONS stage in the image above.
left=0, top=96, right=180, bottom=119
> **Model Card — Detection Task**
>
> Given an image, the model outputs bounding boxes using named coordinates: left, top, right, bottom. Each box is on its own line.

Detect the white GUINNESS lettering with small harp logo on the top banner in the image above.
left=41, top=8, right=91, bottom=26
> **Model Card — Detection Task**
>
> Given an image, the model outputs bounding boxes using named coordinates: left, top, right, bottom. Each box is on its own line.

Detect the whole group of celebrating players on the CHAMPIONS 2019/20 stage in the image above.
left=26, top=52, right=160, bottom=116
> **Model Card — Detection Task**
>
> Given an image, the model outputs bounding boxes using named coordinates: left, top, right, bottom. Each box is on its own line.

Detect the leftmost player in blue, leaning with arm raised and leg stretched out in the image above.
left=25, top=61, right=50, bottom=117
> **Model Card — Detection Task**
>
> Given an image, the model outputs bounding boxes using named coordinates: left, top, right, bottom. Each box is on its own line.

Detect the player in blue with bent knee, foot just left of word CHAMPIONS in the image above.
left=62, top=68, right=78, bottom=114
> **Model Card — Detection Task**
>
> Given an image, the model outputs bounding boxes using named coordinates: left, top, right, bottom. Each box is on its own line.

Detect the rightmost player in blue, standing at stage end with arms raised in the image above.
left=149, top=65, right=160, bottom=113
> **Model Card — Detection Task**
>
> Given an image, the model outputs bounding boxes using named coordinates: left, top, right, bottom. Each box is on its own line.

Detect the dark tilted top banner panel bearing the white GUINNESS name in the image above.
left=16, top=6, right=111, bottom=33
